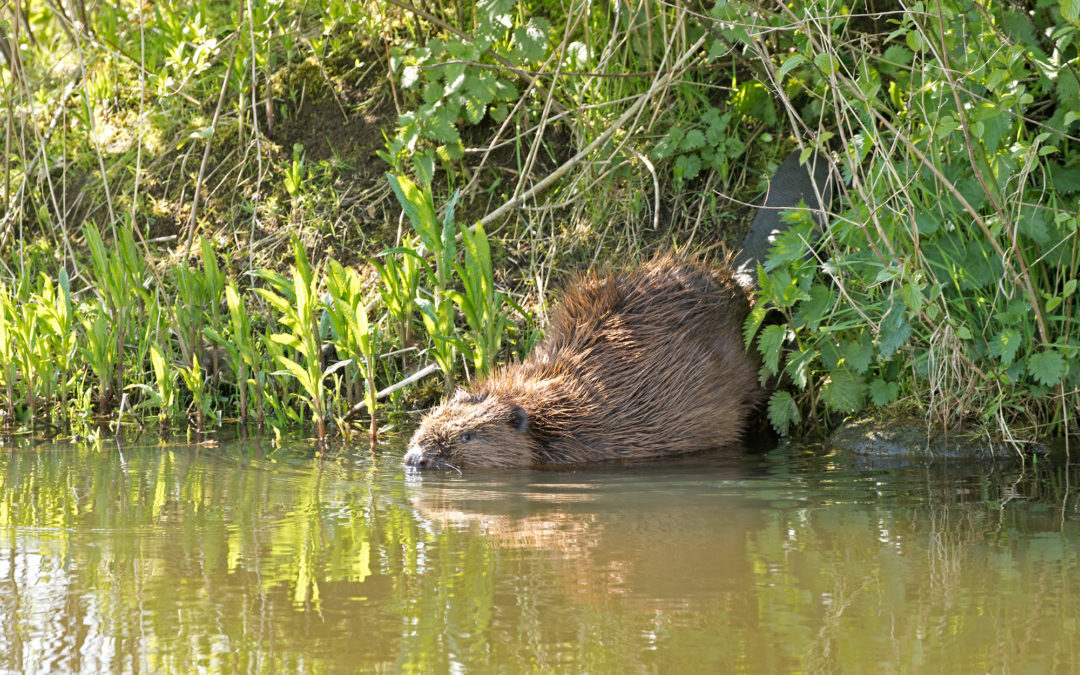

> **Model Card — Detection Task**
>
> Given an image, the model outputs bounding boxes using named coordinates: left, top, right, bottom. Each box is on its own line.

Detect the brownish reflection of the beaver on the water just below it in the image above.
left=409, top=456, right=764, bottom=603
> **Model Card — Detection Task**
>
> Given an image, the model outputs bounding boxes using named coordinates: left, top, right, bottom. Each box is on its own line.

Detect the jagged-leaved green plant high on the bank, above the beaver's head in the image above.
left=383, top=0, right=551, bottom=164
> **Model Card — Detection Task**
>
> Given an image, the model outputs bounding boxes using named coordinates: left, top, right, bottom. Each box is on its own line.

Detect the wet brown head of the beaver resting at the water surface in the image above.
left=405, top=390, right=538, bottom=469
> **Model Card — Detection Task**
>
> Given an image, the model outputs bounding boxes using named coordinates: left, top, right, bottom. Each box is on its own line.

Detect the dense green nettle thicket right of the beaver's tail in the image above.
left=726, top=0, right=1080, bottom=440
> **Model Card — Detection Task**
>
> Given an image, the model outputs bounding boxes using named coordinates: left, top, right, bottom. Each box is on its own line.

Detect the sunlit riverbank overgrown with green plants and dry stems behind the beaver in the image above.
left=0, top=0, right=1080, bottom=441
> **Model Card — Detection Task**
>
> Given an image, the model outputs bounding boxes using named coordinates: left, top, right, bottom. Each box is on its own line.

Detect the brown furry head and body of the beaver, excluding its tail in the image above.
left=406, top=255, right=761, bottom=467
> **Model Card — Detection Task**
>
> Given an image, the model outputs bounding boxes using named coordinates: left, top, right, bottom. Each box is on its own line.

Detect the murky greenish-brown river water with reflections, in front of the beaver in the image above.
left=0, top=432, right=1080, bottom=673
